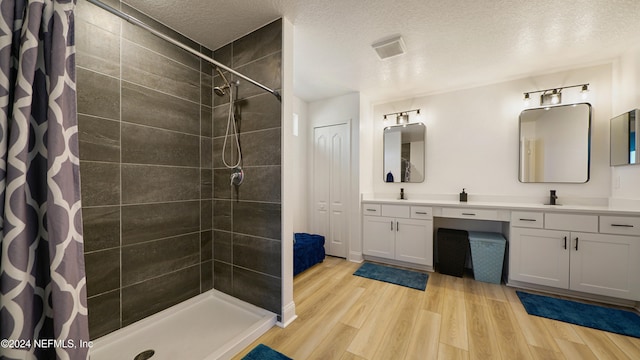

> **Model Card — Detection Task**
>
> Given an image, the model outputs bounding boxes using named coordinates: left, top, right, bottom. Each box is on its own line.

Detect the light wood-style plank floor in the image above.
left=235, top=257, right=640, bottom=360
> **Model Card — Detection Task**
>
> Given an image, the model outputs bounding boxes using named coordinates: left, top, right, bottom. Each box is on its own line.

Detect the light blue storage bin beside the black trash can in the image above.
left=469, top=231, right=507, bottom=284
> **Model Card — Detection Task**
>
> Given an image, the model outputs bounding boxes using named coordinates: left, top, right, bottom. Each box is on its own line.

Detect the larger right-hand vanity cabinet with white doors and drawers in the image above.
left=509, top=212, right=640, bottom=300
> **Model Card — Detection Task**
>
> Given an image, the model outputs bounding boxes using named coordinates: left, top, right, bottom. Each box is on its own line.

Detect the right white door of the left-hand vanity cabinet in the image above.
left=396, top=219, right=433, bottom=266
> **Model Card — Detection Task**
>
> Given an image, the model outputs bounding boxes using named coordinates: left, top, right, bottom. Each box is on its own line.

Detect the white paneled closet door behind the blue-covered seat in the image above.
left=313, top=124, right=351, bottom=258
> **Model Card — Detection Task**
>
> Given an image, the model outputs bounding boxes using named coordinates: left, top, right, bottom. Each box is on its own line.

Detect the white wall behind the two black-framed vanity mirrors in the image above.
left=363, top=64, right=612, bottom=203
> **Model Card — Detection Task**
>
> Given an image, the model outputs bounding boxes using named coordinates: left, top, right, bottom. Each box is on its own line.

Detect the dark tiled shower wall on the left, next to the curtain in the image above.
left=76, top=0, right=213, bottom=339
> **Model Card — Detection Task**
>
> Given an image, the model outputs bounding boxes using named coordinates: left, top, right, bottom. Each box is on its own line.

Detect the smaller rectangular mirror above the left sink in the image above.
left=383, top=123, right=426, bottom=182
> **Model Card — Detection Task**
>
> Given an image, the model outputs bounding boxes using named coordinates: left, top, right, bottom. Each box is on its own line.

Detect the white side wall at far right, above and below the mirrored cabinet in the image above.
left=611, top=50, right=640, bottom=207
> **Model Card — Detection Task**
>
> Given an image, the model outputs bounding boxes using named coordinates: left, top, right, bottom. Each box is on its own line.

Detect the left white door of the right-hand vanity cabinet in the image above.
left=509, top=227, right=570, bottom=289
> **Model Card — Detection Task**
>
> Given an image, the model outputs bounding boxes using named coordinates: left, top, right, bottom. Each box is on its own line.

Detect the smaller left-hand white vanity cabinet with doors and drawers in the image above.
left=362, top=203, right=433, bottom=267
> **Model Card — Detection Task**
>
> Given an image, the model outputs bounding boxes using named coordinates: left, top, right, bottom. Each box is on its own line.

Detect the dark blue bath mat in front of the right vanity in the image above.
left=516, top=291, right=640, bottom=338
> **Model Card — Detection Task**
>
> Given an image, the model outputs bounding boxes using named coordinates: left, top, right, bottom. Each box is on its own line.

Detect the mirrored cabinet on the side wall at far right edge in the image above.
left=610, top=109, right=640, bottom=166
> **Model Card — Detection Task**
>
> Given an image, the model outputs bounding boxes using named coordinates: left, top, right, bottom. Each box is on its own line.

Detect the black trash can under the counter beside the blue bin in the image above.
left=436, top=228, right=469, bottom=277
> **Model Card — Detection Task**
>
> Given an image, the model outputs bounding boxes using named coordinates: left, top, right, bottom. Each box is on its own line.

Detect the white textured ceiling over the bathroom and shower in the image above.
left=121, top=0, right=640, bottom=101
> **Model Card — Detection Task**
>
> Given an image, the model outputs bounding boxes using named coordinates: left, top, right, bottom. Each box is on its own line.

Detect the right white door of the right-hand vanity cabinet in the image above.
left=570, top=232, right=640, bottom=300
